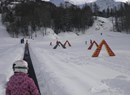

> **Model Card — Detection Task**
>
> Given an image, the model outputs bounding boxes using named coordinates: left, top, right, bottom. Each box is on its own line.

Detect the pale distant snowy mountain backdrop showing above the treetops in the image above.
left=50, top=0, right=123, bottom=11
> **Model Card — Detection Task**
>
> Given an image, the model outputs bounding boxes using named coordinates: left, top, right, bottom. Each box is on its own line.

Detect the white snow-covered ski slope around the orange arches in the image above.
left=0, top=17, right=130, bottom=95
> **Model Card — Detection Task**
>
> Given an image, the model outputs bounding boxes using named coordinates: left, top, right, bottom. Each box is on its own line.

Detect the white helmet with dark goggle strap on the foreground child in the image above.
left=13, top=60, right=28, bottom=73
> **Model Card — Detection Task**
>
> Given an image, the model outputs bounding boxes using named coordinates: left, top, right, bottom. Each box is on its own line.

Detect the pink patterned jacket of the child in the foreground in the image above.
left=6, top=73, right=40, bottom=95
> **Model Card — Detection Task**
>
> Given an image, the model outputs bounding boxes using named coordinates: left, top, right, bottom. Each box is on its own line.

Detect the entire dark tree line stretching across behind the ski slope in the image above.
left=1, top=0, right=130, bottom=37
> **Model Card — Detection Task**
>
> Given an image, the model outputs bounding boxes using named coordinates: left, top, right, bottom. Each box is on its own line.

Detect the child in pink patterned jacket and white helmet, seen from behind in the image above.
left=6, top=60, right=40, bottom=95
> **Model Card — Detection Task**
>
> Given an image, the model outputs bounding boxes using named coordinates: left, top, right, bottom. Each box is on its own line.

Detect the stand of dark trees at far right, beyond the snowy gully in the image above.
left=114, top=3, right=130, bottom=33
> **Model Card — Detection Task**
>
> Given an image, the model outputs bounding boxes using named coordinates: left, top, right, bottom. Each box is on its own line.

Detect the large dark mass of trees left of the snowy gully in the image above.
left=2, top=1, right=94, bottom=36
